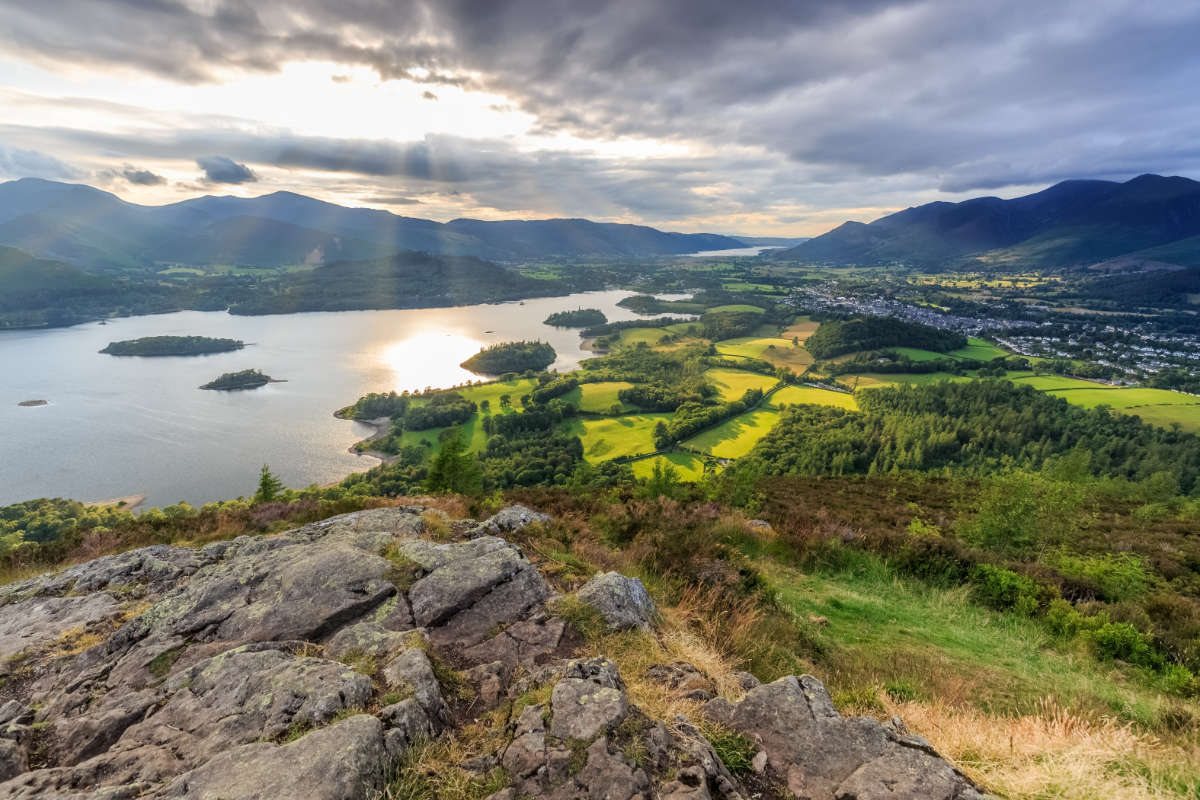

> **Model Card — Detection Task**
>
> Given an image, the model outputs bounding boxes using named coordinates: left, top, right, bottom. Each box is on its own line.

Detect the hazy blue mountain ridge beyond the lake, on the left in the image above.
left=0, top=178, right=744, bottom=271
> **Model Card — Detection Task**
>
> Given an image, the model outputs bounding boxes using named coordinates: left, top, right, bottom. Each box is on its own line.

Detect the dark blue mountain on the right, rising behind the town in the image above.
left=769, top=175, right=1200, bottom=267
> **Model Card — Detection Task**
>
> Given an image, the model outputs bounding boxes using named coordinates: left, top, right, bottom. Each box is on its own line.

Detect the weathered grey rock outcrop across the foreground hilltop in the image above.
left=0, top=507, right=979, bottom=800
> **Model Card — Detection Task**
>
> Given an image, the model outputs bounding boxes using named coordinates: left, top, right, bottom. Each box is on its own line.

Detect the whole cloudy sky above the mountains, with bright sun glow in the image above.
left=0, top=0, right=1200, bottom=236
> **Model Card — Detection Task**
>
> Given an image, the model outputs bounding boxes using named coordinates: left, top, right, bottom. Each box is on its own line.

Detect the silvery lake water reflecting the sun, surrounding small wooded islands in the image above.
left=0, top=291, right=684, bottom=506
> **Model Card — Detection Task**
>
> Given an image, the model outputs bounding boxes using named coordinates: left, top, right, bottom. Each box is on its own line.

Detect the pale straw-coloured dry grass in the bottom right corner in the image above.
left=877, top=692, right=1200, bottom=800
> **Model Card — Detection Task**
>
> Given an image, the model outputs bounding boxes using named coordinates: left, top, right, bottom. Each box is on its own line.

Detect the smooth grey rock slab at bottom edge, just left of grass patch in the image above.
left=154, top=715, right=386, bottom=800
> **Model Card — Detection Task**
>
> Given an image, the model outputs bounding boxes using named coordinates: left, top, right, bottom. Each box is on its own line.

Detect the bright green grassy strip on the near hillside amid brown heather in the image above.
left=755, top=554, right=1163, bottom=724
